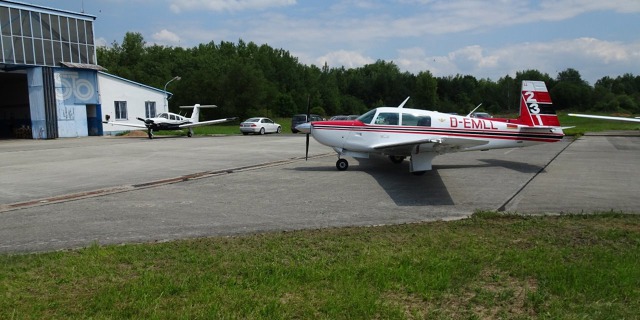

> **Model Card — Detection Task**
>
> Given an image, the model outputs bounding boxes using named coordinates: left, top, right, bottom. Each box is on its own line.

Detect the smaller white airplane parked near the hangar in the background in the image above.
left=102, top=104, right=237, bottom=139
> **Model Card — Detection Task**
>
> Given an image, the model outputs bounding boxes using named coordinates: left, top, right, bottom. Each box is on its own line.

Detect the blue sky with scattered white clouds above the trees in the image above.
left=20, top=0, right=640, bottom=85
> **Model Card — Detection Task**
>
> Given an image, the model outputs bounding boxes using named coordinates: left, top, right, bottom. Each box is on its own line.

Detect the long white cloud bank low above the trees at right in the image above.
left=395, top=38, right=640, bottom=84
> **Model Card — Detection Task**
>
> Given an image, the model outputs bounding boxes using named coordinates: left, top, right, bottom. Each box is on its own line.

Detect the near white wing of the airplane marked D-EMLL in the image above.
left=373, top=138, right=489, bottom=154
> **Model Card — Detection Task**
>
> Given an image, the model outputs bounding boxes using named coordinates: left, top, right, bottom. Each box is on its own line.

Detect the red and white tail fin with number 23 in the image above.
left=518, top=80, right=560, bottom=127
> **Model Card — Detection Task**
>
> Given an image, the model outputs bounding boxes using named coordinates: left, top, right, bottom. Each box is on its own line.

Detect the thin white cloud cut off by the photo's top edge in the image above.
left=169, top=0, right=296, bottom=13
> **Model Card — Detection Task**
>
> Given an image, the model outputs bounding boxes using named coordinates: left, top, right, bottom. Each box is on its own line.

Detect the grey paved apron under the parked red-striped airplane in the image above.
left=0, top=132, right=640, bottom=253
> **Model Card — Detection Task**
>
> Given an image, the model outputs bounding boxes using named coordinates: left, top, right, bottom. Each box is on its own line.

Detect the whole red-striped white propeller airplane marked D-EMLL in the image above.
left=296, top=80, right=564, bottom=175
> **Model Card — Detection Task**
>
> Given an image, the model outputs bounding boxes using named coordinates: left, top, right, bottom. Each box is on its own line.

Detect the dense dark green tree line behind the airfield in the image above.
left=97, top=32, right=640, bottom=118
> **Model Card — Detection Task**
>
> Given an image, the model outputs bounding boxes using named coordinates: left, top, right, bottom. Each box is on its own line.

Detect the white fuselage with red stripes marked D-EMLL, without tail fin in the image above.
left=311, top=108, right=563, bottom=156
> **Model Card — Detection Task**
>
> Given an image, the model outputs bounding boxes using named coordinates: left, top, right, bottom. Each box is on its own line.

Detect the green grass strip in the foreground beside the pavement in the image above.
left=0, top=212, right=640, bottom=319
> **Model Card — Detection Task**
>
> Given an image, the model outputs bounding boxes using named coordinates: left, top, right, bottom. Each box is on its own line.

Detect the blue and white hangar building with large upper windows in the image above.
left=0, top=0, right=168, bottom=139
